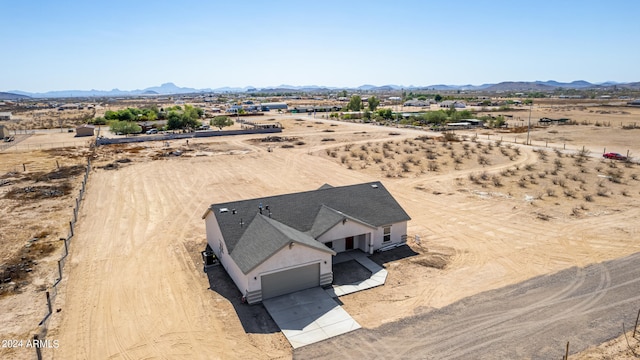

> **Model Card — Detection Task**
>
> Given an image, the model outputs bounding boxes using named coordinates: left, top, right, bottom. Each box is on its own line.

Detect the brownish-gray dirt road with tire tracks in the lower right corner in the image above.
left=294, top=254, right=640, bottom=359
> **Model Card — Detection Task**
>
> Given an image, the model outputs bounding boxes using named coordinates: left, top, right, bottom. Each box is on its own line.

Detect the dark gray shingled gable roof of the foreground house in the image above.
left=203, top=182, right=410, bottom=274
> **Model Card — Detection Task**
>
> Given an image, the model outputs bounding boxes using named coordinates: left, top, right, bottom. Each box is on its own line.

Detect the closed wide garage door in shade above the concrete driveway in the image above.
left=261, top=263, right=320, bottom=300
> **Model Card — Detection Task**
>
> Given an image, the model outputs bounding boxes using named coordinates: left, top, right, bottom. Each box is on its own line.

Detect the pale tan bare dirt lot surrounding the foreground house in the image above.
left=0, top=102, right=640, bottom=359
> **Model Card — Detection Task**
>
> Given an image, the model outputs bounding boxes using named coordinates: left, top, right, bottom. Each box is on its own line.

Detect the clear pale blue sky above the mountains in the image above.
left=0, top=0, right=640, bottom=92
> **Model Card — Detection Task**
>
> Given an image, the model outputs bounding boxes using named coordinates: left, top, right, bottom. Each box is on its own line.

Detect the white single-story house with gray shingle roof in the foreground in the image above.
left=202, top=182, right=410, bottom=304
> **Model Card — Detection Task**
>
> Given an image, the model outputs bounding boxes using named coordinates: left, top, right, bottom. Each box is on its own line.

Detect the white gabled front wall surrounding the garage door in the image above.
left=246, top=243, right=333, bottom=291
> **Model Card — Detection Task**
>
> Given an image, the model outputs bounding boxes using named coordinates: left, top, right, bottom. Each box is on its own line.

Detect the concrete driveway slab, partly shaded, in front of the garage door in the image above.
left=262, top=287, right=360, bottom=349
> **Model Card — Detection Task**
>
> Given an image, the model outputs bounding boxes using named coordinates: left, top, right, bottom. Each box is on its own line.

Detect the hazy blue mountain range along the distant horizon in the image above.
left=0, top=80, right=640, bottom=100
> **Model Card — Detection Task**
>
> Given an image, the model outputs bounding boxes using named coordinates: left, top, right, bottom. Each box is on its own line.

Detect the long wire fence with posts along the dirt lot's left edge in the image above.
left=33, top=159, right=91, bottom=360
